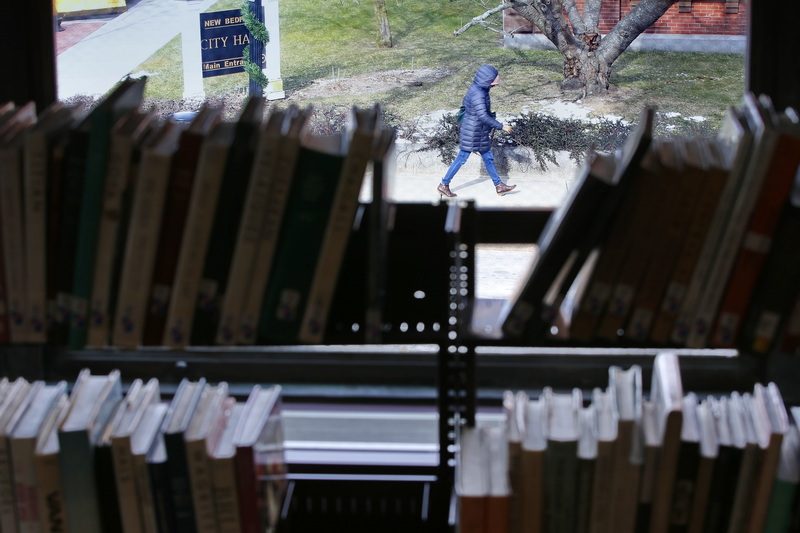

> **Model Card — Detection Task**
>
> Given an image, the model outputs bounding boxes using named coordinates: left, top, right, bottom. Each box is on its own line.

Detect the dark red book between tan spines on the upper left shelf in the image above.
left=142, top=103, right=222, bottom=346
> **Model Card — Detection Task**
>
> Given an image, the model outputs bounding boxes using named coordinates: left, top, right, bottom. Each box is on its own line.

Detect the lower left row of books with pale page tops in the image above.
left=0, top=370, right=287, bottom=533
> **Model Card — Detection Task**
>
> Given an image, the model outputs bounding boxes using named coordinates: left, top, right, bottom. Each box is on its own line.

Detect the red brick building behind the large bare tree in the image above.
left=503, top=0, right=748, bottom=53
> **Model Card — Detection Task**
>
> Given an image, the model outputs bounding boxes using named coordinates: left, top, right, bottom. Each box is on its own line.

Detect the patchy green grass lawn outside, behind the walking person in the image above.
left=135, top=0, right=744, bottom=129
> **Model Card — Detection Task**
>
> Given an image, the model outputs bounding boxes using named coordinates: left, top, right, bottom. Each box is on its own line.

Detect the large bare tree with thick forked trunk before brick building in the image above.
left=453, top=0, right=677, bottom=94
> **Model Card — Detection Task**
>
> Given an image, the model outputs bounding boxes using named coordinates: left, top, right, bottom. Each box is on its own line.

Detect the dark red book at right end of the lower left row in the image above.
left=233, top=385, right=287, bottom=533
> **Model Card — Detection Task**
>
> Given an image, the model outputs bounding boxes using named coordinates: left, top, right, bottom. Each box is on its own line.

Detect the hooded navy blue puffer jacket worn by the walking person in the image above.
left=459, top=65, right=503, bottom=154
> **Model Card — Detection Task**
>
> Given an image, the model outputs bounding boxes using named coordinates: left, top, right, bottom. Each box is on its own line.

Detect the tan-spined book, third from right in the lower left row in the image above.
left=184, top=382, right=230, bottom=532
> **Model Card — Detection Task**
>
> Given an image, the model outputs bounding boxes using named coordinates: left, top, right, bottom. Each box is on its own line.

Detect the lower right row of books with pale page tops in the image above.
left=456, top=352, right=800, bottom=533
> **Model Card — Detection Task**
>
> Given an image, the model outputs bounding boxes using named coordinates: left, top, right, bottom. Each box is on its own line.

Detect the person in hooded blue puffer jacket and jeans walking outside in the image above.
left=436, top=65, right=516, bottom=198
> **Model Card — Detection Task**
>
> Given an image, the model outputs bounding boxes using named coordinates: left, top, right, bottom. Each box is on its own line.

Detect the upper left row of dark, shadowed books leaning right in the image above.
left=0, top=78, right=394, bottom=349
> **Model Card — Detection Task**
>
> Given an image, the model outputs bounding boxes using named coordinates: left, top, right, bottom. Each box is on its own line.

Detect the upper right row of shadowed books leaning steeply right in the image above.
left=502, top=93, right=800, bottom=354
